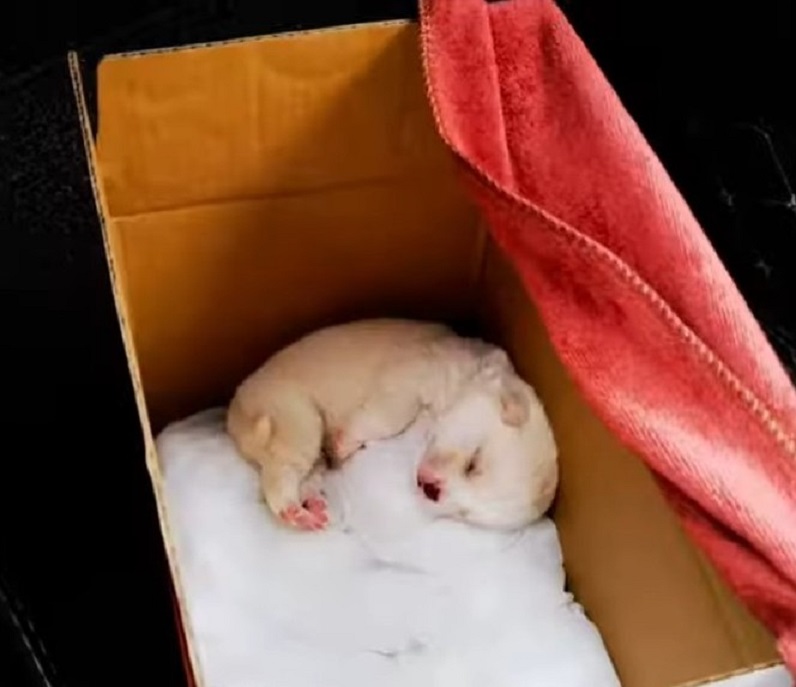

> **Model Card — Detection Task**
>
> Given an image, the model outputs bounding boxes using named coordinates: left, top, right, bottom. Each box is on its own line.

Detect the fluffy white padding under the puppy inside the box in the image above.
left=158, top=411, right=619, bottom=687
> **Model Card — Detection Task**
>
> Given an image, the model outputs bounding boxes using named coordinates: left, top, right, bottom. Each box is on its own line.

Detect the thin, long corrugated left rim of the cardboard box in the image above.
left=67, top=52, right=205, bottom=687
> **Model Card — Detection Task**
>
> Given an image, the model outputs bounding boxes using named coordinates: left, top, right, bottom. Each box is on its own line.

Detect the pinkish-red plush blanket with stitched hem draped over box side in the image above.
left=421, top=0, right=796, bottom=671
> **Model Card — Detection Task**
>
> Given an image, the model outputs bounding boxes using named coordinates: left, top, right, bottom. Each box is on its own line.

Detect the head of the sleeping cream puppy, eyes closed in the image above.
left=417, top=351, right=558, bottom=529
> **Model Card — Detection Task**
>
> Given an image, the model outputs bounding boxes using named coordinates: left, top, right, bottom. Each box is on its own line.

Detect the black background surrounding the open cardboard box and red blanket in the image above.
left=0, top=0, right=796, bottom=687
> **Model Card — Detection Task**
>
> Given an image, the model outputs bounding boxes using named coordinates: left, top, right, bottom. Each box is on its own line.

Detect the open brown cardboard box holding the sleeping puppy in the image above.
left=68, top=22, right=776, bottom=687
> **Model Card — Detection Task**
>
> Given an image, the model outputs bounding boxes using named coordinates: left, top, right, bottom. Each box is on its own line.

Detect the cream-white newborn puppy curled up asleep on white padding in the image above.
left=227, top=319, right=558, bottom=529
